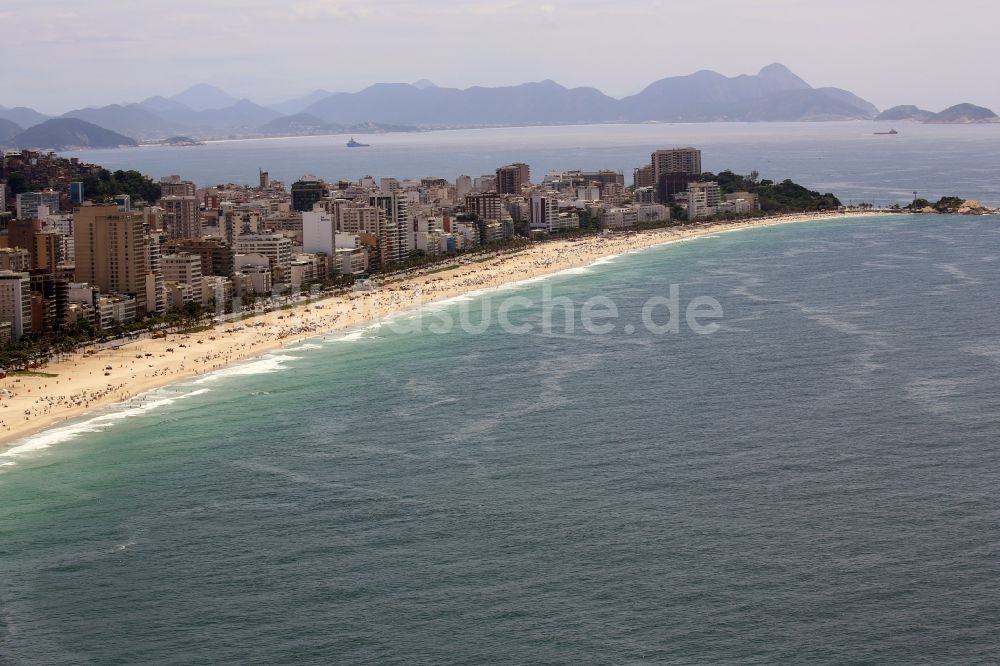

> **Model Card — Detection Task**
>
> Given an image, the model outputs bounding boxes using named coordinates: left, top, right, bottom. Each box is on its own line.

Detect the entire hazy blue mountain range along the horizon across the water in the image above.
left=0, top=63, right=996, bottom=144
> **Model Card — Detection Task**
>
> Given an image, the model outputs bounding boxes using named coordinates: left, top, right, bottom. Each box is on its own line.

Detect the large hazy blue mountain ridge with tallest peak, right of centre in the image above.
left=305, top=64, right=878, bottom=126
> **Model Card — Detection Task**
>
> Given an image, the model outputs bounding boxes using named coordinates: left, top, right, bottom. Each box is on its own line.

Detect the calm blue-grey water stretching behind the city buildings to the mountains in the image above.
left=68, top=121, right=1000, bottom=206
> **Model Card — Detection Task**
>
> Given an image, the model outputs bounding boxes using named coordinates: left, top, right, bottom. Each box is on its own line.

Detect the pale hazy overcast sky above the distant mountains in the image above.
left=7, top=0, right=1000, bottom=113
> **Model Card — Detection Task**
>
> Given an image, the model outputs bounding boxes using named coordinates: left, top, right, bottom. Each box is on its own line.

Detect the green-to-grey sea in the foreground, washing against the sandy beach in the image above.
left=0, top=217, right=1000, bottom=664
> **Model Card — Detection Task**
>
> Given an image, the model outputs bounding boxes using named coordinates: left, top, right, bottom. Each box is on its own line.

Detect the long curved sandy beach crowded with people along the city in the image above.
left=0, top=211, right=905, bottom=460
